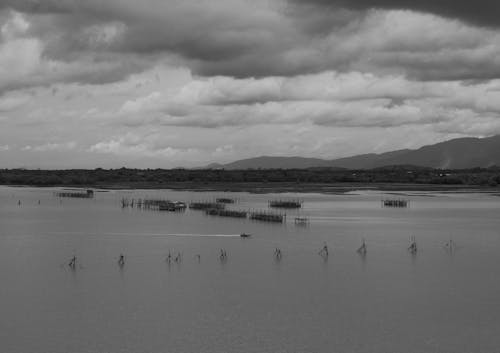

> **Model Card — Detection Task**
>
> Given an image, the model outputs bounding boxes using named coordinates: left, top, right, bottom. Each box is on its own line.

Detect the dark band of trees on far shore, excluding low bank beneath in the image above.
left=0, top=167, right=500, bottom=187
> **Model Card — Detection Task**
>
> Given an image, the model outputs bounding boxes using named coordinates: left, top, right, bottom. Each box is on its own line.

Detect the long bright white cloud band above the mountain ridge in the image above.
left=112, top=72, right=500, bottom=128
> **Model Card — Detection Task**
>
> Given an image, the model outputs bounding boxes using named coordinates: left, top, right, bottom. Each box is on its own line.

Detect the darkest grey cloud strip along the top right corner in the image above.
left=290, top=0, right=500, bottom=27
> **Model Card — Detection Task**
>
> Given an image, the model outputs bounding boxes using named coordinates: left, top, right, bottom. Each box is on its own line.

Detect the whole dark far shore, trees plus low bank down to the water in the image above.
left=0, top=167, right=500, bottom=193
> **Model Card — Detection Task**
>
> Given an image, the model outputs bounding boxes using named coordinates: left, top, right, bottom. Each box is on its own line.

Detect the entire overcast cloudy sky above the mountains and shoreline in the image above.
left=0, top=0, right=500, bottom=168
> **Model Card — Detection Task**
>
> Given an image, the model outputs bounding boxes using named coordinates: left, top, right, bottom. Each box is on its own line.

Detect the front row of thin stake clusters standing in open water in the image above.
left=68, top=236, right=456, bottom=270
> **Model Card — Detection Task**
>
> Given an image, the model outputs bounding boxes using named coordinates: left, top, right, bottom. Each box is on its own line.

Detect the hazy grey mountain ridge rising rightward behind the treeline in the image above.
left=207, top=135, right=500, bottom=170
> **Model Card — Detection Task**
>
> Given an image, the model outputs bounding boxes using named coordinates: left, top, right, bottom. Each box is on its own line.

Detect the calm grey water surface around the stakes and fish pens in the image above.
left=0, top=187, right=500, bottom=353
